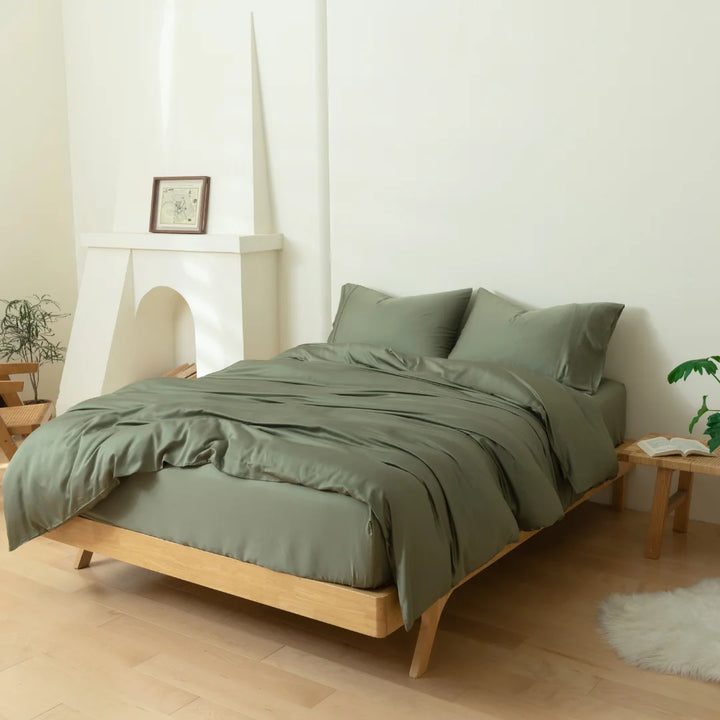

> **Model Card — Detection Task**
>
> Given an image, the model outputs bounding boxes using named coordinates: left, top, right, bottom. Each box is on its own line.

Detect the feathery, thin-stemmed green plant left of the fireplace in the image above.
left=0, top=295, right=67, bottom=403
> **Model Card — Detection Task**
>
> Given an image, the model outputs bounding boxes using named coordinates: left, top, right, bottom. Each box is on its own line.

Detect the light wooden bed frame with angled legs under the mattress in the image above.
left=46, top=462, right=630, bottom=678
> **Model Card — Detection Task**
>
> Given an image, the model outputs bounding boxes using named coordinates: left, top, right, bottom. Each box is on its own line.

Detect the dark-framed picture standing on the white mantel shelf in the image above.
left=150, top=175, right=210, bottom=234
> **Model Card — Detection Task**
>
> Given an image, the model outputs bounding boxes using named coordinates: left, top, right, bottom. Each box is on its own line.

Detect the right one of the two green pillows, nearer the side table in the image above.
left=450, top=288, right=625, bottom=393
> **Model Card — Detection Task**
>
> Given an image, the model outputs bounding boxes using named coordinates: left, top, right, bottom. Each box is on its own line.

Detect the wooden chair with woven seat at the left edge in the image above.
left=0, top=363, right=55, bottom=461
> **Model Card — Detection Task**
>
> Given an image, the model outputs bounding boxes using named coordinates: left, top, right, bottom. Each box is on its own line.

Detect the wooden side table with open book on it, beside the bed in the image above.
left=617, top=434, right=720, bottom=559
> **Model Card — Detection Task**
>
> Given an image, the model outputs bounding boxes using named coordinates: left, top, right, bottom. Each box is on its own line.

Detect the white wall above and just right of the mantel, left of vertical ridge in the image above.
left=63, top=0, right=327, bottom=348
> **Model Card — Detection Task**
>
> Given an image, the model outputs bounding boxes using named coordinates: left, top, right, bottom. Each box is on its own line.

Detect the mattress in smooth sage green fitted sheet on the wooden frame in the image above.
left=83, top=379, right=626, bottom=588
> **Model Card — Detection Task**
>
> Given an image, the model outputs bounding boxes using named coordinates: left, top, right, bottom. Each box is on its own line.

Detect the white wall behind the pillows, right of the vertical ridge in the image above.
left=328, top=0, right=720, bottom=522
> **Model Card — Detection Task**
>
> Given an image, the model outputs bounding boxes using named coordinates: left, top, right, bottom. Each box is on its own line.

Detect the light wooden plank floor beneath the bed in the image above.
left=0, top=503, right=720, bottom=720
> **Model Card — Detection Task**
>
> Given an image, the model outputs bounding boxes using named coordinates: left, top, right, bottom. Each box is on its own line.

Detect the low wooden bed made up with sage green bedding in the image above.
left=3, top=286, right=626, bottom=677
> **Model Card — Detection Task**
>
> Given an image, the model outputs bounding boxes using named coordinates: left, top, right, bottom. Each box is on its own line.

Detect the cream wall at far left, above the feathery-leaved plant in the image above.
left=0, top=0, right=76, bottom=399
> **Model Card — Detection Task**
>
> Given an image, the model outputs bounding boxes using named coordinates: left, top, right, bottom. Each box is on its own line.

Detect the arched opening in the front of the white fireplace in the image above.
left=104, top=286, right=196, bottom=391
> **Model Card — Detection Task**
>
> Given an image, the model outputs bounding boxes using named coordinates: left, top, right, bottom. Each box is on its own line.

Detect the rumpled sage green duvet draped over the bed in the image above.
left=3, top=344, right=616, bottom=627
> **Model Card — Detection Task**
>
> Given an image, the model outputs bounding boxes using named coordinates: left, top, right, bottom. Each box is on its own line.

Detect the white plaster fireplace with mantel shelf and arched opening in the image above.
left=57, top=233, right=283, bottom=412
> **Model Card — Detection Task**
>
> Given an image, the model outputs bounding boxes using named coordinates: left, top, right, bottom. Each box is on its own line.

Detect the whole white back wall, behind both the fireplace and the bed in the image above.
left=57, top=0, right=720, bottom=522
